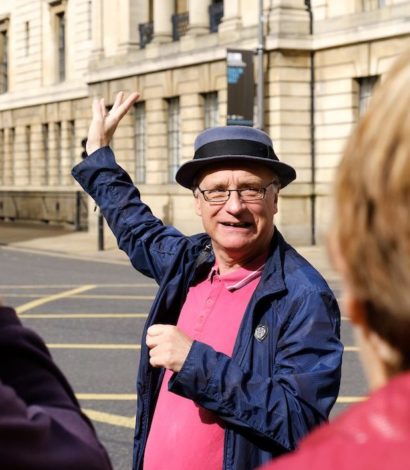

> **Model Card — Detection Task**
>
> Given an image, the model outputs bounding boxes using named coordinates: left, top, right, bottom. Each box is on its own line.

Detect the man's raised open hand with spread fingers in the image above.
left=86, top=91, right=140, bottom=155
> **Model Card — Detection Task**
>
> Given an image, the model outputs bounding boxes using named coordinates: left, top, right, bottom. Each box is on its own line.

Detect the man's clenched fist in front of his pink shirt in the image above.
left=146, top=325, right=193, bottom=372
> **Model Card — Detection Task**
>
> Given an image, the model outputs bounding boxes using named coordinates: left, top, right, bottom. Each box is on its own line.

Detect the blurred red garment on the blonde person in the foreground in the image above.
left=262, top=372, right=410, bottom=470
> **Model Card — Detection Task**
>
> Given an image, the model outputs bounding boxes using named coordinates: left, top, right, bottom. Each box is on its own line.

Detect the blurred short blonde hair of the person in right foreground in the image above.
left=332, top=51, right=410, bottom=369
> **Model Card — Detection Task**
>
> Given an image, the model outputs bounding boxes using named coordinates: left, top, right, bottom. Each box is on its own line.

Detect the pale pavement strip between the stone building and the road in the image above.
left=0, top=222, right=339, bottom=283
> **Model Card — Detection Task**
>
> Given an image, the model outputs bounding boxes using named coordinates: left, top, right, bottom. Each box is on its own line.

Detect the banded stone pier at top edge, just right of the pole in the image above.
left=268, top=0, right=310, bottom=37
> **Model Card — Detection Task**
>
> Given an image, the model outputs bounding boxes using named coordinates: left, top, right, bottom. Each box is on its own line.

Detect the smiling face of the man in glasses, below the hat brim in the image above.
left=196, top=166, right=278, bottom=261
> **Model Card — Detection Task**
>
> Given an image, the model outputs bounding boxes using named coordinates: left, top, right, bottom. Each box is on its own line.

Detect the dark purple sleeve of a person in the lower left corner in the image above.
left=0, top=307, right=111, bottom=470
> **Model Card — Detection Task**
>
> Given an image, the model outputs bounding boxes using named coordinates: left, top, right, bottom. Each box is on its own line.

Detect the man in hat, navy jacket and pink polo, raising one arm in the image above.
left=73, top=93, right=342, bottom=470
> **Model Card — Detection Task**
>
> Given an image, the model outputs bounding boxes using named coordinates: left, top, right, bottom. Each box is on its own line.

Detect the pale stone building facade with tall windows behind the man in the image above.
left=0, top=0, right=410, bottom=244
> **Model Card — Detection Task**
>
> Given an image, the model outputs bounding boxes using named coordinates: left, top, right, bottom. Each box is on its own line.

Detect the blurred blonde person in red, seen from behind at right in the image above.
left=264, top=51, right=410, bottom=470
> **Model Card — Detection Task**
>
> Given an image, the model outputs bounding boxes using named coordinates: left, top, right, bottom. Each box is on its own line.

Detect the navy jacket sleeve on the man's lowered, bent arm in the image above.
left=169, top=293, right=343, bottom=450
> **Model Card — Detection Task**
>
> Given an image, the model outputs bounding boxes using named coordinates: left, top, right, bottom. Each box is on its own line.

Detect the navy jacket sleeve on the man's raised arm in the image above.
left=72, top=147, right=189, bottom=283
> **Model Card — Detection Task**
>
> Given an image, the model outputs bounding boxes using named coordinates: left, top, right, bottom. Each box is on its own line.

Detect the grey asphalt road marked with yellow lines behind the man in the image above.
left=0, top=247, right=366, bottom=470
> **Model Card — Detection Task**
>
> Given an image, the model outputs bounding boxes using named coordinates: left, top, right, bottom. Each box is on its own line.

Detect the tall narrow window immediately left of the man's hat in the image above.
left=168, top=98, right=181, bottom=183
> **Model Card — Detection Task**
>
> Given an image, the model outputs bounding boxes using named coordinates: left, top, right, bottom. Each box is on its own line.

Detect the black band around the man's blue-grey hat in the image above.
left=194, top=139, right=278, bottom=160
